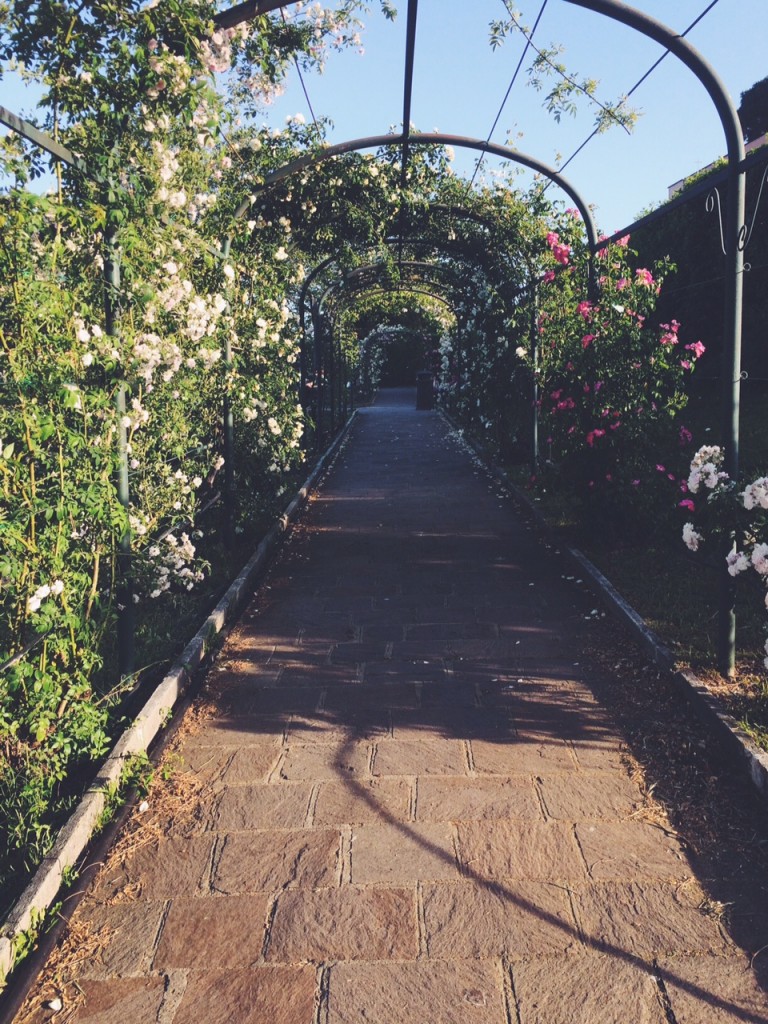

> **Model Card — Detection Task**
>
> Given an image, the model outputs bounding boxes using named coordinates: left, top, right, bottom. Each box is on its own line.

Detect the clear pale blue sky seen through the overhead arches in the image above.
left=0, top=0, right=768, bottom=231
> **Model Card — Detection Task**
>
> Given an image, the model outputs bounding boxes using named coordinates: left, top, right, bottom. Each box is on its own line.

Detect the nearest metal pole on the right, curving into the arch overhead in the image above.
left=565, top=0, right=744, bottom=676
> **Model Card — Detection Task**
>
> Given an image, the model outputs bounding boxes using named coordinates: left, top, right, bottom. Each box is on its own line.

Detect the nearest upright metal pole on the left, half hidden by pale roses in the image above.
left=103, top=219, right=136, bottom=679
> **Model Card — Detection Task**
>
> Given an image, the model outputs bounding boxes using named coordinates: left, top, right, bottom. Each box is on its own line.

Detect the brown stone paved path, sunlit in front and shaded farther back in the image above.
left=15, top=392, right=768, bottom=1024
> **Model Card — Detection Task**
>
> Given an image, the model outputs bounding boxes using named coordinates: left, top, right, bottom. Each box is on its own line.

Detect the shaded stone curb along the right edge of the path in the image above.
left=440, top=411, right=768, bottom=803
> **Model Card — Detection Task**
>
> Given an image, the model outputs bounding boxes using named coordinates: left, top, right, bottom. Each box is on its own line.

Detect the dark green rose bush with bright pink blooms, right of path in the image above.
left=539, top=224, right=705, bottom=529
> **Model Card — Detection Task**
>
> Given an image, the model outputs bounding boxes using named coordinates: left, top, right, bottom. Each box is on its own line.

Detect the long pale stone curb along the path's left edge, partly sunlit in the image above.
left=0, top=410, right=357, bottom=979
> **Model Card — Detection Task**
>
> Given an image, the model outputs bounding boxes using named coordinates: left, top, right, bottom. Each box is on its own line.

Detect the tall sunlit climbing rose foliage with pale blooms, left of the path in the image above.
left=0, top=0, right=394, bottom=909
